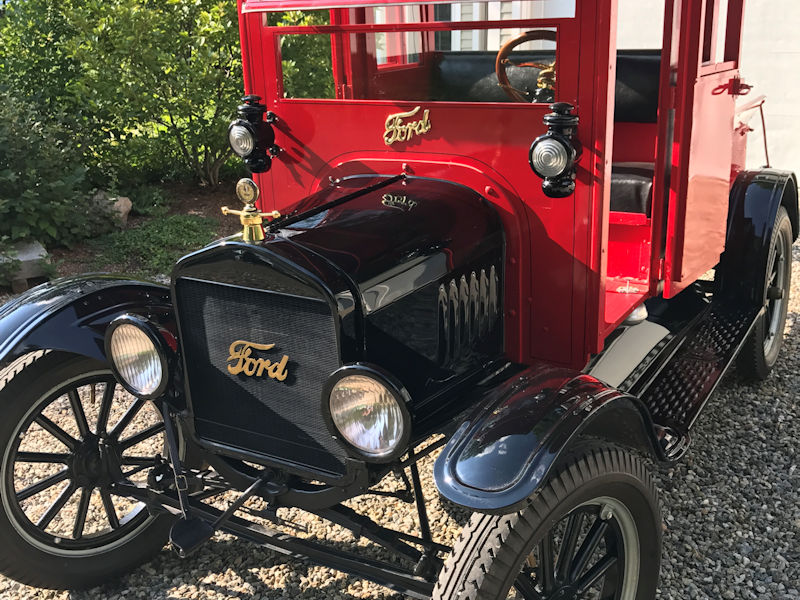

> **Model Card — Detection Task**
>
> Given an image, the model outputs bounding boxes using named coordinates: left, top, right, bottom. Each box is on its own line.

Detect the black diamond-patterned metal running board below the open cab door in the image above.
left=638, top=302, right=761, bottom=460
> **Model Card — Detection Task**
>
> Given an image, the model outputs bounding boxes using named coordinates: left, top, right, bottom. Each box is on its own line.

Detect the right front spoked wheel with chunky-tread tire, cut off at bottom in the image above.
left=433, top=448, right=661, bottom=600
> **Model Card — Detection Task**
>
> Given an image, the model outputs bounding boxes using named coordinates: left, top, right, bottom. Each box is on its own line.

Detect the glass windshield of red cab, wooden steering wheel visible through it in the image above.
left=264, top=0, right=575, bottom=103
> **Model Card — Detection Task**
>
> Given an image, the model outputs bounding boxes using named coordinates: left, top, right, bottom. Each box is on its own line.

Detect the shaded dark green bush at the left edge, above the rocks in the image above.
left=0, top=90, right=110, bottom=245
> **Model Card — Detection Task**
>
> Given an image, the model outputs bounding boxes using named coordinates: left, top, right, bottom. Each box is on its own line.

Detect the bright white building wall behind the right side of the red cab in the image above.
left=618, top=0, right=800, bottom=173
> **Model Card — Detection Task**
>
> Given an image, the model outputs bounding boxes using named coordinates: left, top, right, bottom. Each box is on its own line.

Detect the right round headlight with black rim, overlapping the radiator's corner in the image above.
left=328, top=367, right=410, bottom=460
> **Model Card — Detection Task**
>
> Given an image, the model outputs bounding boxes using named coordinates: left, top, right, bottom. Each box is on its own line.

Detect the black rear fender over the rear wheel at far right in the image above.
left=717, top=169, right=800, bottom=306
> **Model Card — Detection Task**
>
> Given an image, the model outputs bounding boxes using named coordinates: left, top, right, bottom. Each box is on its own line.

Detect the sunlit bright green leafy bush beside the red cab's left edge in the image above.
left=0, top=0, right=242, bottom=186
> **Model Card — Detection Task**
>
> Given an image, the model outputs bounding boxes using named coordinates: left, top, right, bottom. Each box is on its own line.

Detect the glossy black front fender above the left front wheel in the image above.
left=0, top=275, right=175, bottom=371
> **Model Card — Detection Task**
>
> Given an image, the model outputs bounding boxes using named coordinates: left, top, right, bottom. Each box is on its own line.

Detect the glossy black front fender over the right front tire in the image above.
left=433, top=364, right=663, bottom=514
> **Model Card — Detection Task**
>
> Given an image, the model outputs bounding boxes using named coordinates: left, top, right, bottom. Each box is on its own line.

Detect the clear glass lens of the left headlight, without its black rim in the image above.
left=108, top=323, right=164, bottom=396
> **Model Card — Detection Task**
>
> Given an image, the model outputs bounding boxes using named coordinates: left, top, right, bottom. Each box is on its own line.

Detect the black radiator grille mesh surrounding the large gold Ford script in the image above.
left=176, top=279, right=345, bottom=474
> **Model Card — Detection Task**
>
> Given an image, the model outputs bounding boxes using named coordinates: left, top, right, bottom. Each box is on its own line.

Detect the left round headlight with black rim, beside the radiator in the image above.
left=106, top=315, right=168, bottom=398
